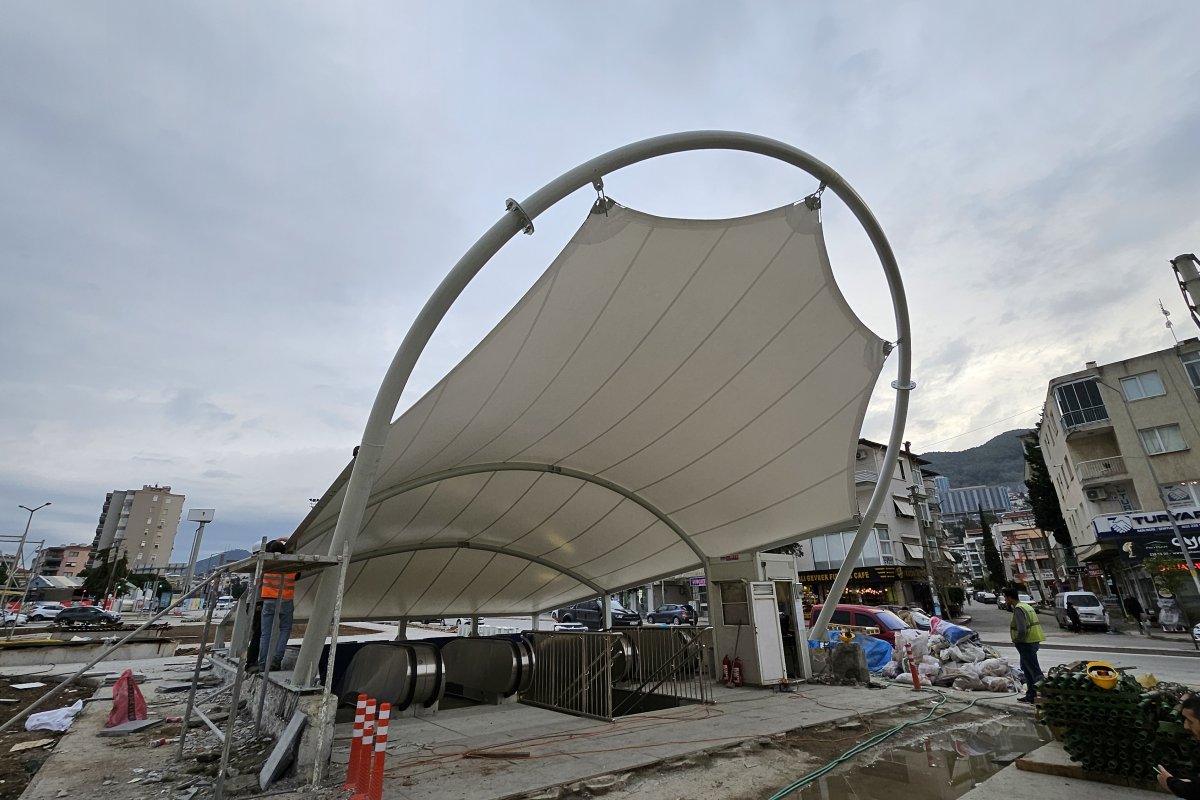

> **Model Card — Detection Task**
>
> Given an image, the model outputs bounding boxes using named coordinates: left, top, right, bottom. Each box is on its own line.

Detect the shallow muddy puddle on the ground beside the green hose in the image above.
left=792, top=718, right=1051, bottom=800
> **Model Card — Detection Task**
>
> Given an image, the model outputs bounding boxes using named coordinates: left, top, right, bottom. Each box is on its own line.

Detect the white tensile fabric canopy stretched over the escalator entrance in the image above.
left=292, top=203, right=886, bottom=619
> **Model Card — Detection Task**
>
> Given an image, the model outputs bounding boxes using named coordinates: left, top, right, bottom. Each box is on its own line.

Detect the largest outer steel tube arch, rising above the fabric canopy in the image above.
left=293, top=131, right=914, bottom=686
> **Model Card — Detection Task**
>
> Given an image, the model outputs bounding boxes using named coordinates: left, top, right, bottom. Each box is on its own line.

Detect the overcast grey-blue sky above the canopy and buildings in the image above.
left=0, top=1, right=1200, bottom=560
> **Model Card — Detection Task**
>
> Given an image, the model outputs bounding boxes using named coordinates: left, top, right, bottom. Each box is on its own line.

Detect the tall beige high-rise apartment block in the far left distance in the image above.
left=88, top=485, right=185, bottom=572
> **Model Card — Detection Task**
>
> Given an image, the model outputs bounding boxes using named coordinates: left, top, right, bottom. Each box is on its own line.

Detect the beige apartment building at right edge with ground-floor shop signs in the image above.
left=1039, top=338, right=1200, bottom=608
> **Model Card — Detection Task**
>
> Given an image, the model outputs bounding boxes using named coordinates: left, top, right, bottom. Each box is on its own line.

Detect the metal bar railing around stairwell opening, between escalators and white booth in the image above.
left=522, top=627, right=714, bottom=720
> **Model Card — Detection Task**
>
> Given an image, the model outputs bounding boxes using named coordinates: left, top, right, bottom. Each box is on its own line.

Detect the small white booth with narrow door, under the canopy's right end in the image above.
left=708, top=553, right=810, bottom=686
